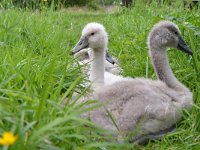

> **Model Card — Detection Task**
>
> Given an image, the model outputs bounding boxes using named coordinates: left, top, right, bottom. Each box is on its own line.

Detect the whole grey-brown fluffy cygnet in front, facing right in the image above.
left=81, top=21, right=193, bottom=142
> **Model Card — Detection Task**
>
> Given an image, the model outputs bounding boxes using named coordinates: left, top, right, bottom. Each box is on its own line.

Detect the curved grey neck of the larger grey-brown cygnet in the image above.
left=150, top=48, right=188, bottom=91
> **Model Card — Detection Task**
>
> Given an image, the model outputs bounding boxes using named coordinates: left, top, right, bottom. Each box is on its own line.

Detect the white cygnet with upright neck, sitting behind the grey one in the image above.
left=73, top=23, right=124, bottom=88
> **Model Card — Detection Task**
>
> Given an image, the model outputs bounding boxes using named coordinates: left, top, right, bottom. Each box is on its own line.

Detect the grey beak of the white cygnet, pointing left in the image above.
left=72, top=36, right=89, bottom=55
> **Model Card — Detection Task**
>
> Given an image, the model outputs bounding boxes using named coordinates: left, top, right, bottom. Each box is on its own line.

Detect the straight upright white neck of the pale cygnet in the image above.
left=90, top=49, right=105, bottom=87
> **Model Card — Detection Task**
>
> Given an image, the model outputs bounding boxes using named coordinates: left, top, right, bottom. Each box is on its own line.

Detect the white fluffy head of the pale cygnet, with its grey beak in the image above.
left=72, top=22, right=114, bottom=64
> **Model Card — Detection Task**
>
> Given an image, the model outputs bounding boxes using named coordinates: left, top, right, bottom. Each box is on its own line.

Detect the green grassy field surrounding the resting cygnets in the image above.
left=0, top=2, right=200, bottom=150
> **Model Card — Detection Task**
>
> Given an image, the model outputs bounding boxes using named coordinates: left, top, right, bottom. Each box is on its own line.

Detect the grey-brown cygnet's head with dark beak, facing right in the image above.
left=148, top=21, right=192, bottom=55
